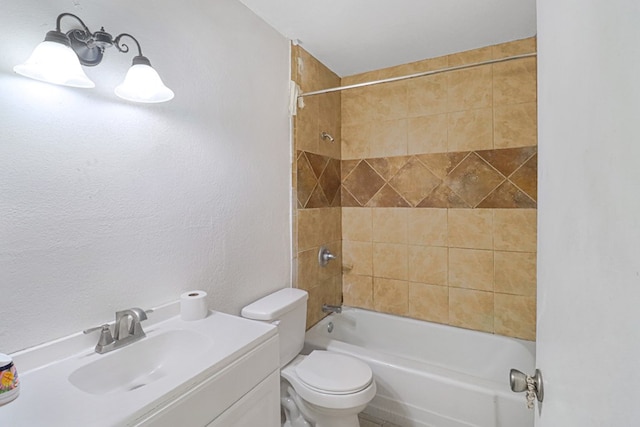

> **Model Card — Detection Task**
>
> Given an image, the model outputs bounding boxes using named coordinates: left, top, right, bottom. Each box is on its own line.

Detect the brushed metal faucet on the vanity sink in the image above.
left=82, top=307, right=150, bottom=354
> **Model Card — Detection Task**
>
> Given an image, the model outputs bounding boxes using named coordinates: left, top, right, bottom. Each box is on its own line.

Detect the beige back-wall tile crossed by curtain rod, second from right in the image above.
left=446, top=65, right=493, bottom=112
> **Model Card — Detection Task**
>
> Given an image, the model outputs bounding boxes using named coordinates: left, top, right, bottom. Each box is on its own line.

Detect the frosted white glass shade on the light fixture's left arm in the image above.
left=13, top=41, right=96, bottom=88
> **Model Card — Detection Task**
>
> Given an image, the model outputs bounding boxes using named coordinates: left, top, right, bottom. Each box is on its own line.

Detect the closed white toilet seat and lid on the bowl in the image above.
left=280, top=350, right=376, bottom=409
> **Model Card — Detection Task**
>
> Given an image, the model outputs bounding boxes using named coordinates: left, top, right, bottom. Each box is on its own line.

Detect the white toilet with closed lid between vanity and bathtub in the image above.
left=242, top=288, right=376, bottom=427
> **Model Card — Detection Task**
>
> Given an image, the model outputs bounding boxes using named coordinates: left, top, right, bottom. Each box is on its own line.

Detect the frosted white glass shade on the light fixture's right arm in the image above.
left=115, top=62, right=174, bottom=103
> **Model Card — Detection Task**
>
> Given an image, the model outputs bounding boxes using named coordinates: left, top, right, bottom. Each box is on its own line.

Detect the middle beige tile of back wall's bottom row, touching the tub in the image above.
left=409, top=283, right=449, bottom=323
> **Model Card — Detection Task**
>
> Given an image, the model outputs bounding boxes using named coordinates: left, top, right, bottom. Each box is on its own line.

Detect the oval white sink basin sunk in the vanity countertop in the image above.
left=69, top=329, right=213, bottom=394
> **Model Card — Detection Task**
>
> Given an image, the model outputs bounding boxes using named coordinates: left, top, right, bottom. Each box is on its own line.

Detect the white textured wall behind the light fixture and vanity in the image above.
left=0, top=0, right=290, bottom=352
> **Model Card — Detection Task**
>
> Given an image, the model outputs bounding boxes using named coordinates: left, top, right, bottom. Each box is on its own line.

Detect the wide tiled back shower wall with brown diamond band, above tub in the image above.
left=341, top=38, right=537, bottom=339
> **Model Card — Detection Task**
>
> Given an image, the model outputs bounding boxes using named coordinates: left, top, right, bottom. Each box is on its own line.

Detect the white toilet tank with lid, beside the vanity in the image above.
left=241, top=288, right=308, bottom=367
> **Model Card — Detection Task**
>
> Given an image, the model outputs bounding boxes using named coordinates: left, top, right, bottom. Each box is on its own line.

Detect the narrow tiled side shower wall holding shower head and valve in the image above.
left=291, top=46, right=342, bottom=327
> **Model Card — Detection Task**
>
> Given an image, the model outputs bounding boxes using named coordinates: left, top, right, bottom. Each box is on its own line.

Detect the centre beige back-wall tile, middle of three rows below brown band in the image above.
left=408, top=246, right=448, bottom=286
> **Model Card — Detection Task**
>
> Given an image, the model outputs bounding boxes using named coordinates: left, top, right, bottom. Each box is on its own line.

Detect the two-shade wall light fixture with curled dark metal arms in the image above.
left=13, top=13, right=173, bottom=102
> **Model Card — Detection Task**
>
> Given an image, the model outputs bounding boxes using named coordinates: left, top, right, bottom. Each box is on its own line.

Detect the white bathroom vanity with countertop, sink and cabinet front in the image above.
left=0, top=303, right=280, bottom=427
